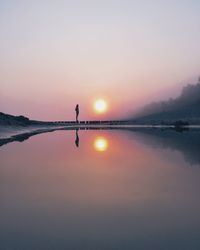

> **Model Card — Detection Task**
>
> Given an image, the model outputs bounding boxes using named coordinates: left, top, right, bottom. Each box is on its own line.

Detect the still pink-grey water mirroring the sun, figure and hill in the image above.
left=0, top=130, right=200, bottom=250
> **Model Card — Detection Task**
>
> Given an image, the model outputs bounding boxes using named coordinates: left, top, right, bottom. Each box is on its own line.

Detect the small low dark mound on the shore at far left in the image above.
left=0, top=112, right=31, bottom=126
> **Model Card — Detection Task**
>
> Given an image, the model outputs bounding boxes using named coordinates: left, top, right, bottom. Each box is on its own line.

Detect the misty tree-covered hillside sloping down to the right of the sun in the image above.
left=131, top=79, right=200, bottom=124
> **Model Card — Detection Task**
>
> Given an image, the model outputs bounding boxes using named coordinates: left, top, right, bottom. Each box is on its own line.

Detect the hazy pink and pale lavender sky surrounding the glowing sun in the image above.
left=0, top=0, right=200, bottom=120
